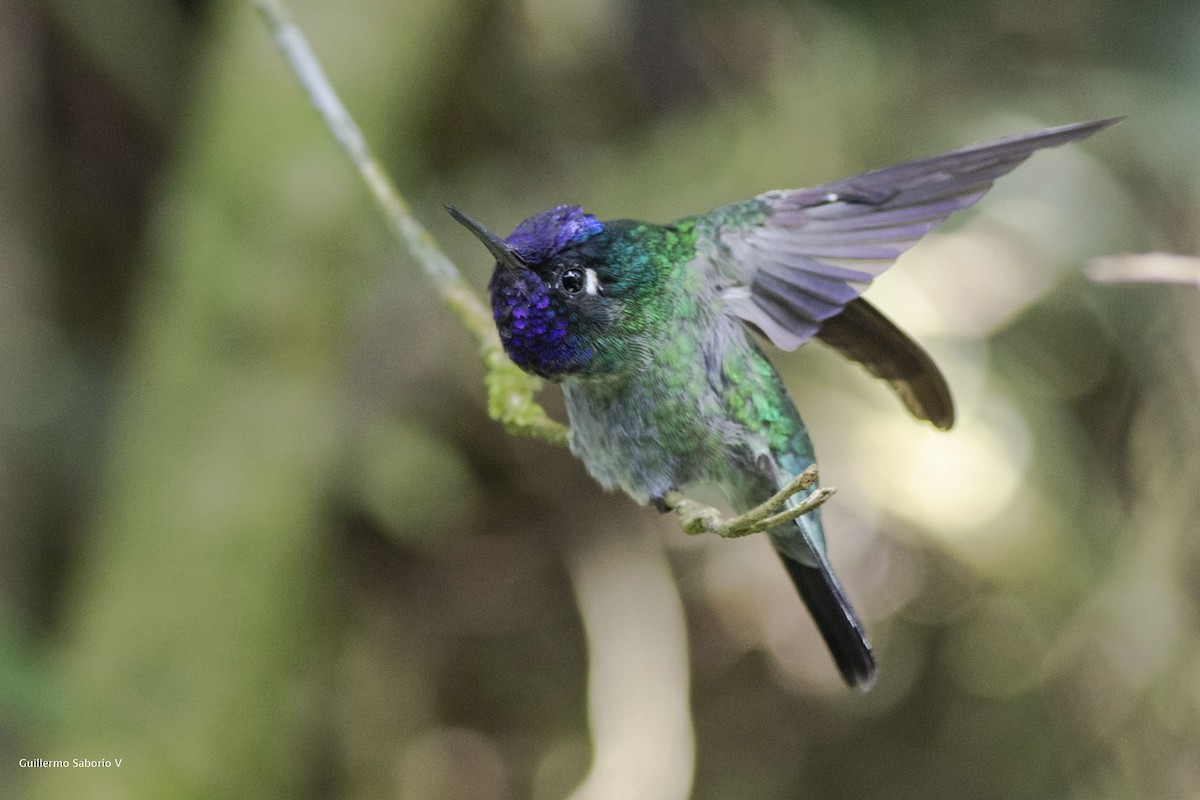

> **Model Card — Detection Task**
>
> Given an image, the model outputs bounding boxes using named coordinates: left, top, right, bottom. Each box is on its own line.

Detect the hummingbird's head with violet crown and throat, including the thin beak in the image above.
left=448, top=205, right=631, bottom=380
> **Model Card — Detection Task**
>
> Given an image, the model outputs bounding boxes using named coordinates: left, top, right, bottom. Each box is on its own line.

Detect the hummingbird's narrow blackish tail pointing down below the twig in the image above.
left=780, top=553, right=875, bottom=692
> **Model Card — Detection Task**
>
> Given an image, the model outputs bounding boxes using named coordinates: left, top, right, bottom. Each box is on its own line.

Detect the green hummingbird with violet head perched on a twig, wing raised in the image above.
left=448, top=119, right=1118, bottom=691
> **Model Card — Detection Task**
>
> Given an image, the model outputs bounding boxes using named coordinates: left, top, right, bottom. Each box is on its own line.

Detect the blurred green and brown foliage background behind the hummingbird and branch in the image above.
left=0, top=0, right=1200, bottom=800
